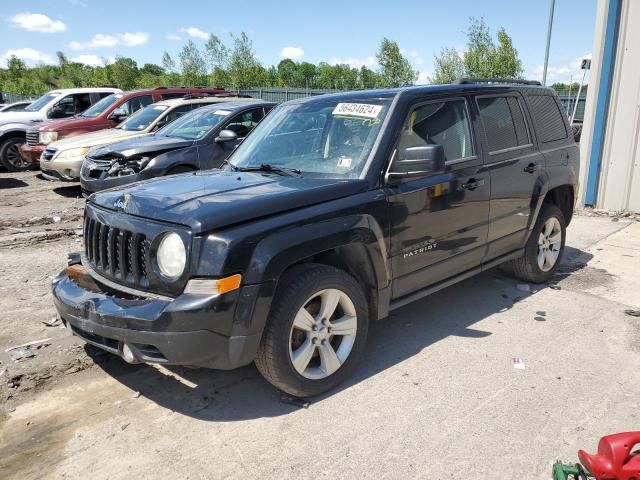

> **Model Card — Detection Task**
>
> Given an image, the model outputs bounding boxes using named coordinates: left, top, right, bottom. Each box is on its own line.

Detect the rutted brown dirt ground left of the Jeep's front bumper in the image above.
left=0, top=168, right=94, bottom=409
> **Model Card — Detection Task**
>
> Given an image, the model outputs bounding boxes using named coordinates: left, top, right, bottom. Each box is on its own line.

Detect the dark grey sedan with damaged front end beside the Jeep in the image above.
left=80, top=99, right=275, bottom=195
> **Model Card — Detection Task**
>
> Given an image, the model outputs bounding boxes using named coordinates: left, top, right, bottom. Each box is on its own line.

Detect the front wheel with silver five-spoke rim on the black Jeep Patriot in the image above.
left=255, top=264, right=369, bottom=398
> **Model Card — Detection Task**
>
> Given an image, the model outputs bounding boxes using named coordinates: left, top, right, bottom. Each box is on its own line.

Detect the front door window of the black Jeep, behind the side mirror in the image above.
left=398, top=100, right=474, bottom=161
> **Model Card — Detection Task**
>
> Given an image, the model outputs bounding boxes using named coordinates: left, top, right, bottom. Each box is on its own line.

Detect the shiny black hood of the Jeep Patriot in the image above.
left=90, top=170, right=368, bottom=234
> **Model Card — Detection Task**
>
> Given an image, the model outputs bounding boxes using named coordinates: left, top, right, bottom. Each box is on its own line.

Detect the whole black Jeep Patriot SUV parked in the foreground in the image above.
left=53, top=81, right=578, bottom=397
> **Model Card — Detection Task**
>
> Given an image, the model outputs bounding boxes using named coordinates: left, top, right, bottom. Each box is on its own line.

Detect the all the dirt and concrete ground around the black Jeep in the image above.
left=0, top=168, right=640, bottom=480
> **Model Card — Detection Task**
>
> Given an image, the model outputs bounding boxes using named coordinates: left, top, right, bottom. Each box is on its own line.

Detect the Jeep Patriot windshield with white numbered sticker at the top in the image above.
left=230, top=98, right=391, bottom=178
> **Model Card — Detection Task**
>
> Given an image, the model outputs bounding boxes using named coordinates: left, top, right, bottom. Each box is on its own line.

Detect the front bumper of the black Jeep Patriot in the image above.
left=52, top=256, right=272, bottom=370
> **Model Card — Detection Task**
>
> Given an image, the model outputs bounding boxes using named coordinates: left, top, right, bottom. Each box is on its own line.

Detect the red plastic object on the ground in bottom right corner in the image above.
left=578, top=432, right=640, bottom=480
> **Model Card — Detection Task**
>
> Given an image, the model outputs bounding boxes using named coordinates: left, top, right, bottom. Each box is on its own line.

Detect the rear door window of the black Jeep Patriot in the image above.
left=478, top=97, right=531, bottom=152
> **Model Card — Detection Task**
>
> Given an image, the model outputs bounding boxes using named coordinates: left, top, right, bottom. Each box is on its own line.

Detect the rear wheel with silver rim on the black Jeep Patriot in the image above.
left=502, top=203, right=566, bottom=283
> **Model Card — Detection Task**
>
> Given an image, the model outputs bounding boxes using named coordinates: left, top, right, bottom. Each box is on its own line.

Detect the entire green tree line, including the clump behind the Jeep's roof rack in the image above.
left=0, top=18, right=523, bottom=95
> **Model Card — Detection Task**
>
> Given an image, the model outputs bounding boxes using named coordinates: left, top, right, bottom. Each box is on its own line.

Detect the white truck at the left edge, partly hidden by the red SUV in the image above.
left=0, top=87, right=121, bottom=172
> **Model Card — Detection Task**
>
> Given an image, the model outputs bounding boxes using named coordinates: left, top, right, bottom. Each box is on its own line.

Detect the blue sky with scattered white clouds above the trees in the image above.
left=0, top=0, right=596, bottom=84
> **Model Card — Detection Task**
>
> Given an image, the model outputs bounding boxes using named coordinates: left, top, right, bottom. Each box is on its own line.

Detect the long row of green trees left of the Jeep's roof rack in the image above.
left=0, top=32, right=418, bottom=95
